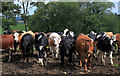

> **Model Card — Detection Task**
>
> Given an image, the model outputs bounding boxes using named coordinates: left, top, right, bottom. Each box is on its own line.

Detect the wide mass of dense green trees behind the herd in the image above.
left=28, top=2, right=118, bottom=34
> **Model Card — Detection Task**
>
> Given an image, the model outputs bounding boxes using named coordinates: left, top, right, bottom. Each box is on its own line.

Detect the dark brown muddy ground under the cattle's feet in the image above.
left=2, top=52, right=120, bottom=75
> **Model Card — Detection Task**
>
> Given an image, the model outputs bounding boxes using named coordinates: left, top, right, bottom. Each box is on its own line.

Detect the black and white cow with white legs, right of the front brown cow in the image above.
left=89, top=32, right=114, bottom=65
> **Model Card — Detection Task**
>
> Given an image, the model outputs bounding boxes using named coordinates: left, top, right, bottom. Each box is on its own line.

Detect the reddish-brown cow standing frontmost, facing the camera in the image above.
left=75, top=35, right=94, bottom=71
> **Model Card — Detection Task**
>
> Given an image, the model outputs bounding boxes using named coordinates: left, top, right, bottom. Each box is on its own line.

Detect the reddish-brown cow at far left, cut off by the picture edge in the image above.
left=0, top=35, right=14, bottom=61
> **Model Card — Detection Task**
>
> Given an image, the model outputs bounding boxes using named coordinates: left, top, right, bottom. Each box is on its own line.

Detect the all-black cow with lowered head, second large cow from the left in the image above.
left=20, top=33, right=33, bottom=62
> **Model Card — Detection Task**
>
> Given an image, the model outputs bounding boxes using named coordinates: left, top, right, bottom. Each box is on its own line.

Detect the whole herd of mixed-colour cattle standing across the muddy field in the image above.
left=0, top=29, right=120, bottom=71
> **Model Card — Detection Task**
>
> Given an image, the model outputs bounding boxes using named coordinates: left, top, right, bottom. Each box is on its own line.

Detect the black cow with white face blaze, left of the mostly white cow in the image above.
left=35, top=32, right=48, bottom=65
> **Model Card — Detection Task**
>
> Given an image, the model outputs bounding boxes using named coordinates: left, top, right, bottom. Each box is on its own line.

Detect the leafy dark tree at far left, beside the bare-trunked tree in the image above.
left=2, top=2, right=21, bottom=30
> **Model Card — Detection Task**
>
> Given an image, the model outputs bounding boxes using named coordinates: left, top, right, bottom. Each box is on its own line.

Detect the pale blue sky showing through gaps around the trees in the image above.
left=14, top=0, right=120, bottom=15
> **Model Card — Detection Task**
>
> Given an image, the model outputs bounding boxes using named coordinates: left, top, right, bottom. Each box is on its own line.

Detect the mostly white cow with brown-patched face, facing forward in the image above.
left=48, top=32, right=61, bottom=58
